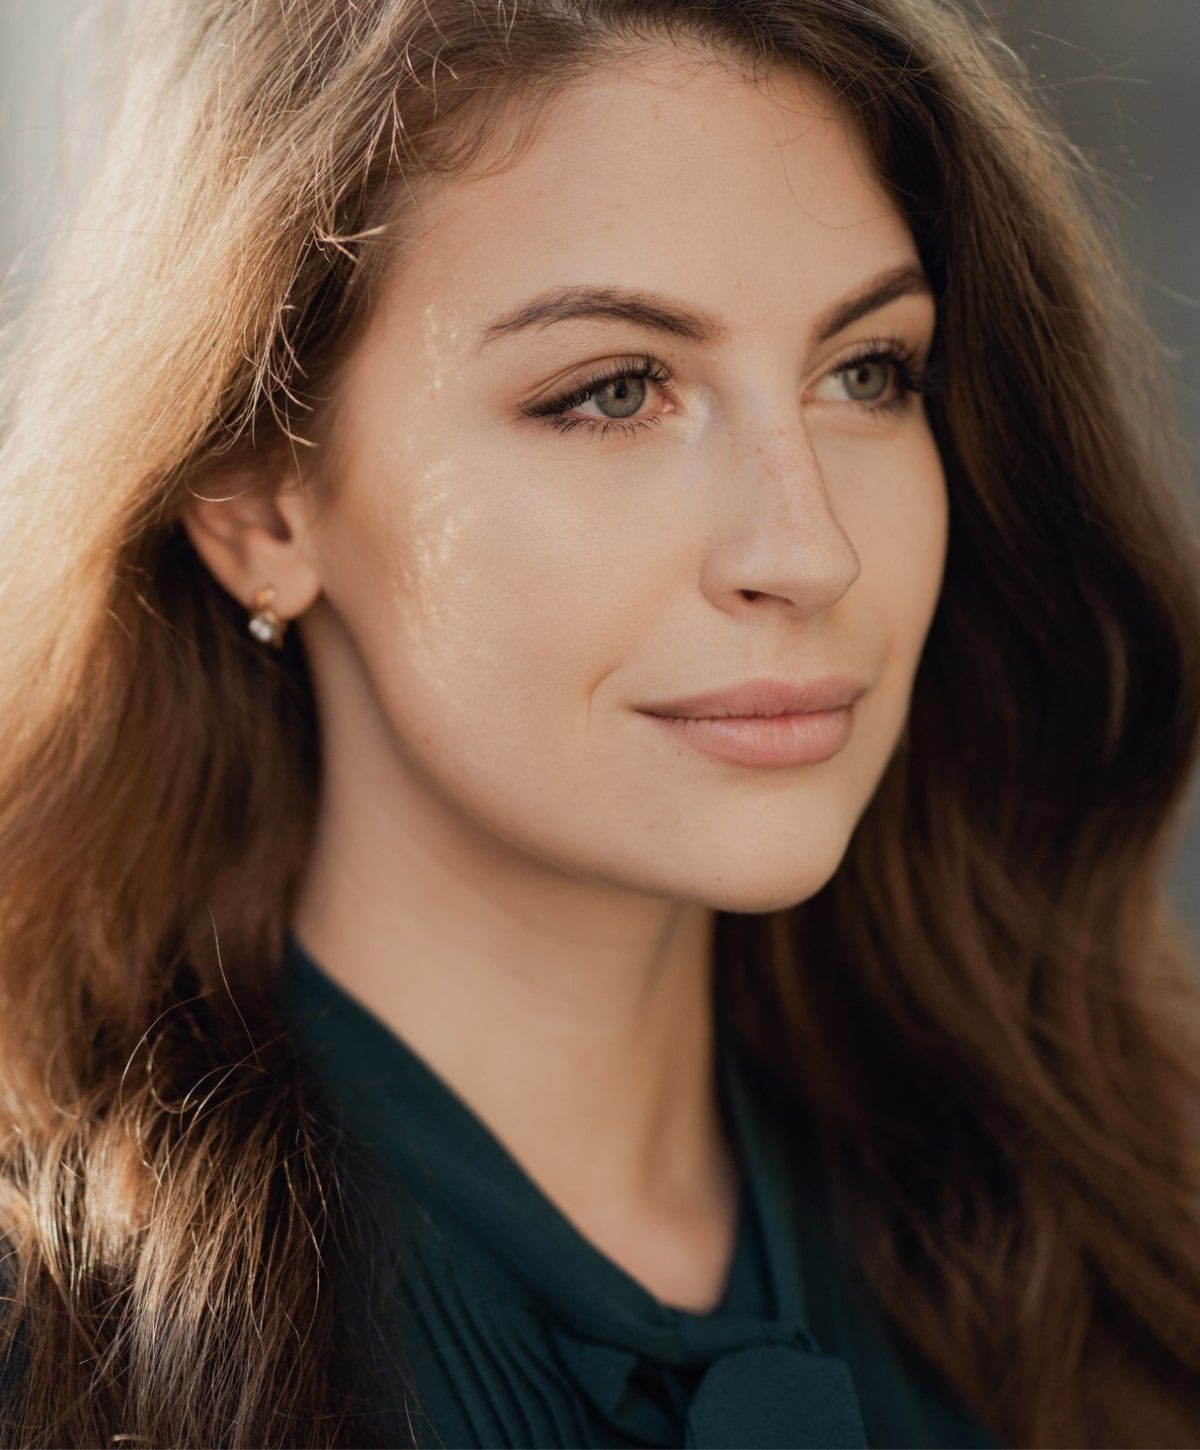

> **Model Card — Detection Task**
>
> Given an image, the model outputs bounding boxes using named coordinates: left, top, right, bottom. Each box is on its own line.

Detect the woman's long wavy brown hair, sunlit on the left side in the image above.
left=0, top=0, right=1200, bottom=1446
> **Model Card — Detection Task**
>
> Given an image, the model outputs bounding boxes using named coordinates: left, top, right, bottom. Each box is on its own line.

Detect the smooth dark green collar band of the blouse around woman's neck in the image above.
left=283, top=929, right=820, bottom=1363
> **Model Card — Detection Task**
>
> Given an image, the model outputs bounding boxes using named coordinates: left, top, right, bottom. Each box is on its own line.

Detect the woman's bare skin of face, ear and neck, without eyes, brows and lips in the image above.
left=187, top=49, right=946, bottom=1308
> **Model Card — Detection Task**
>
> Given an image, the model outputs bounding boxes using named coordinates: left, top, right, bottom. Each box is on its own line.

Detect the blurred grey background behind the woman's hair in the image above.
left=0, top=0, right=1200, bottom=943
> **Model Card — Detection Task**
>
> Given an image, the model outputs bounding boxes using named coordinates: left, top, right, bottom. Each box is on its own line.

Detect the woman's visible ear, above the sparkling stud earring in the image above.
left=181, top=465, right=320, bottom=619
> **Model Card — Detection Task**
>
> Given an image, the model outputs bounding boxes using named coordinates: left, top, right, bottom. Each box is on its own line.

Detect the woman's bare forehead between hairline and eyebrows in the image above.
left=356, top=52, right=916, bottom=365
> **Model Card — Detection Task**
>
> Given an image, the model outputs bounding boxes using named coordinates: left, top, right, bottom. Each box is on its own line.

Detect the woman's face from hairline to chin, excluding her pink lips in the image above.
left=288, top=51, right=946, bottom=912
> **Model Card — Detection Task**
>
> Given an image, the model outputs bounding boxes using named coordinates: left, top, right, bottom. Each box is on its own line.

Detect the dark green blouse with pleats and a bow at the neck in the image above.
left=284, top=934, right=997, bottom=1450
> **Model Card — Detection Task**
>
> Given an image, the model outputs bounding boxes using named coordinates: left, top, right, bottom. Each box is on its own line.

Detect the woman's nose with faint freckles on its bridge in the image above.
left=703, top=420, right=862, bottom=615
